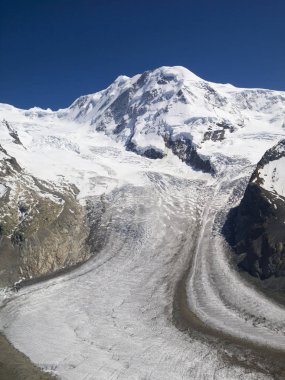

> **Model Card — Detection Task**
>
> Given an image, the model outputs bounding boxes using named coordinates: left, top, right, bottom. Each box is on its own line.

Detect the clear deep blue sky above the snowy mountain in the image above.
left=0, top=0, right=285, bottom=109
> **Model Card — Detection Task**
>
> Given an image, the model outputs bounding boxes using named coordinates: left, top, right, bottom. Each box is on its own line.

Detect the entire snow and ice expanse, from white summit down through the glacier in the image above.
left=0, top=67, right=285, bottom=380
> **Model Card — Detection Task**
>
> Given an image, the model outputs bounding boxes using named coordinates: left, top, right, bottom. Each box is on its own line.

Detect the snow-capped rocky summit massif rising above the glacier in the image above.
left=58, top=67, right=285, bottom=171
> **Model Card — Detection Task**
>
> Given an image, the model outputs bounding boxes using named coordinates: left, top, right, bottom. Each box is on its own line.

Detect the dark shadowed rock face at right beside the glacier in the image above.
left=227, top=140, right=285, bottom=279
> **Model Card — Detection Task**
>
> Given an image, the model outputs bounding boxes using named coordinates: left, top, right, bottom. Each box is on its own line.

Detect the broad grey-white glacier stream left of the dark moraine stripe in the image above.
left=0, top=158, right=278, bottom=380
